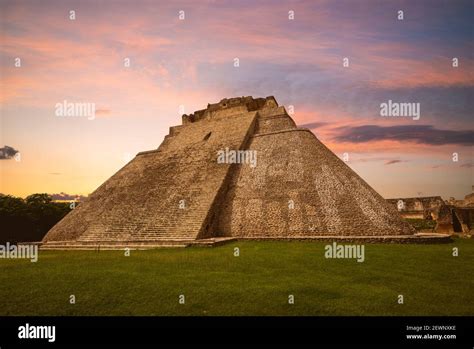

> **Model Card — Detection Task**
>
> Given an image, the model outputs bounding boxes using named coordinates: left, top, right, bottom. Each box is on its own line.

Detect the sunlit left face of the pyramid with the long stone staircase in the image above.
left=44, top=112, right=256, bottom=241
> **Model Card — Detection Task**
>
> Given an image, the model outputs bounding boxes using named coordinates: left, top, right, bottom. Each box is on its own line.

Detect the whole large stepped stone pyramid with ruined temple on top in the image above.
left=43, top=97, right=415, bottom=246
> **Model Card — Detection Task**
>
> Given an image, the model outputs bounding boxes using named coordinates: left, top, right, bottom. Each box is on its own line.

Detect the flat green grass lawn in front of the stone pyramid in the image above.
left=0, top=239, right=474, bottom=315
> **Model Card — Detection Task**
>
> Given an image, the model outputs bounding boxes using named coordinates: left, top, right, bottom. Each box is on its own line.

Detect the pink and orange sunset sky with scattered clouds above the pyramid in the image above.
left=0, top=0, right=474, bottom=199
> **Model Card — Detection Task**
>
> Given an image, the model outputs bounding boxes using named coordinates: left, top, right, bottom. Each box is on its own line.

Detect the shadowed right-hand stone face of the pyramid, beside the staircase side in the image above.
left=218, top=118, right=414, bottom=237
